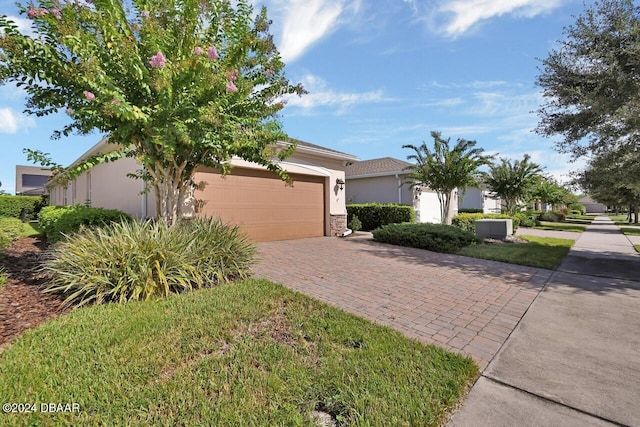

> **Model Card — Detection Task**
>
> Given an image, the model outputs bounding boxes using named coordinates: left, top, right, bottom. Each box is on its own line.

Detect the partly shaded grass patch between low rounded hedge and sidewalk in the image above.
left=459, top=236, right=574, bottom=270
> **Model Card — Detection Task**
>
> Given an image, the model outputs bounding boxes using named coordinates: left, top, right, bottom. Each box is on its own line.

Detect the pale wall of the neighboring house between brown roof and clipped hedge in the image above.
left=346, top=175, right=413, bottom=205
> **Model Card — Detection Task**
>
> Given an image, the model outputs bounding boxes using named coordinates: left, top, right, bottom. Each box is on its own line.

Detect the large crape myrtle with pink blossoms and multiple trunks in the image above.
left=0, top=0, right=304, bottom=223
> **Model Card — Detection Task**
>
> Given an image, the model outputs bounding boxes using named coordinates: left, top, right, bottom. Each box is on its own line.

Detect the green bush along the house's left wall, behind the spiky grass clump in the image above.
left=38, top=205, right=132, bottom=242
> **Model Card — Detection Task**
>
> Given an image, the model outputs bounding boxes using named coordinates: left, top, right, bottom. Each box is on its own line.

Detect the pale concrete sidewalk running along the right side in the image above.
left=449, top=216, right=640, bottom=426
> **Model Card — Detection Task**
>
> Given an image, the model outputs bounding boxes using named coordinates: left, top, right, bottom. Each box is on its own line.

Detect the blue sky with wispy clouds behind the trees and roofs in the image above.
left=0, top=0, right=583, bottom=193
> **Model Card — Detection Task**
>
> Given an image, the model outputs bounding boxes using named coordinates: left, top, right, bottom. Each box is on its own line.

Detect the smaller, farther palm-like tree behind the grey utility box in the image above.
left=484, top=154, right=542, bottom=215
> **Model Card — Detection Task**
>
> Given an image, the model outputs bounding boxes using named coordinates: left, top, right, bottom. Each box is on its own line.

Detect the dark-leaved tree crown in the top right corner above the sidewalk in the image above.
left=537, top=0, right=640, bottom=157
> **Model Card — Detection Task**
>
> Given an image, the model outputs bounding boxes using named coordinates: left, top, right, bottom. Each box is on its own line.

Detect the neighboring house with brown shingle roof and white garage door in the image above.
left=345, top=157, right=458, bottom=223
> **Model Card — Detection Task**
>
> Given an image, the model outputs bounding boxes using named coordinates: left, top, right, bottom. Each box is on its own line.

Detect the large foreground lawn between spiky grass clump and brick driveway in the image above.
left=0, top=280, right=478, bottom=426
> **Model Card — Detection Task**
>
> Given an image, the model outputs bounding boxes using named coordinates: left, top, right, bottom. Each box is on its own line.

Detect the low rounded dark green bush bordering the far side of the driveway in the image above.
left=373, top=223, right=482, bottom=253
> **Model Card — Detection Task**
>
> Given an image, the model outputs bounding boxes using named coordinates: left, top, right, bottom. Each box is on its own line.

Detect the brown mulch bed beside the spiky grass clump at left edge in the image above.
left=0, top=237, right=69, bottom=351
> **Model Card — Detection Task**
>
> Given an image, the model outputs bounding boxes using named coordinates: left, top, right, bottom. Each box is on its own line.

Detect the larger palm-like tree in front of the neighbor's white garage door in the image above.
left=402, top=131, right=492, bottom=224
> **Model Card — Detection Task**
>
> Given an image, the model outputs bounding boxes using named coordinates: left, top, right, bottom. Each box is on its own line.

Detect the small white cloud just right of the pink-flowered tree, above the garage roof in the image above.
left=287, top=74, right=392, bottom=114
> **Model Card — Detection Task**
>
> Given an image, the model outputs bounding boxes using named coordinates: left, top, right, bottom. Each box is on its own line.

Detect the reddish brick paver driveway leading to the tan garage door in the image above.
left=253, top=236, right=552, bottom=370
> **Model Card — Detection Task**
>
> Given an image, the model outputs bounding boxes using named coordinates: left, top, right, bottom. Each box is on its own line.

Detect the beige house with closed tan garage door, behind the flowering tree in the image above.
left=48, top=139, right=358, bottom=241
